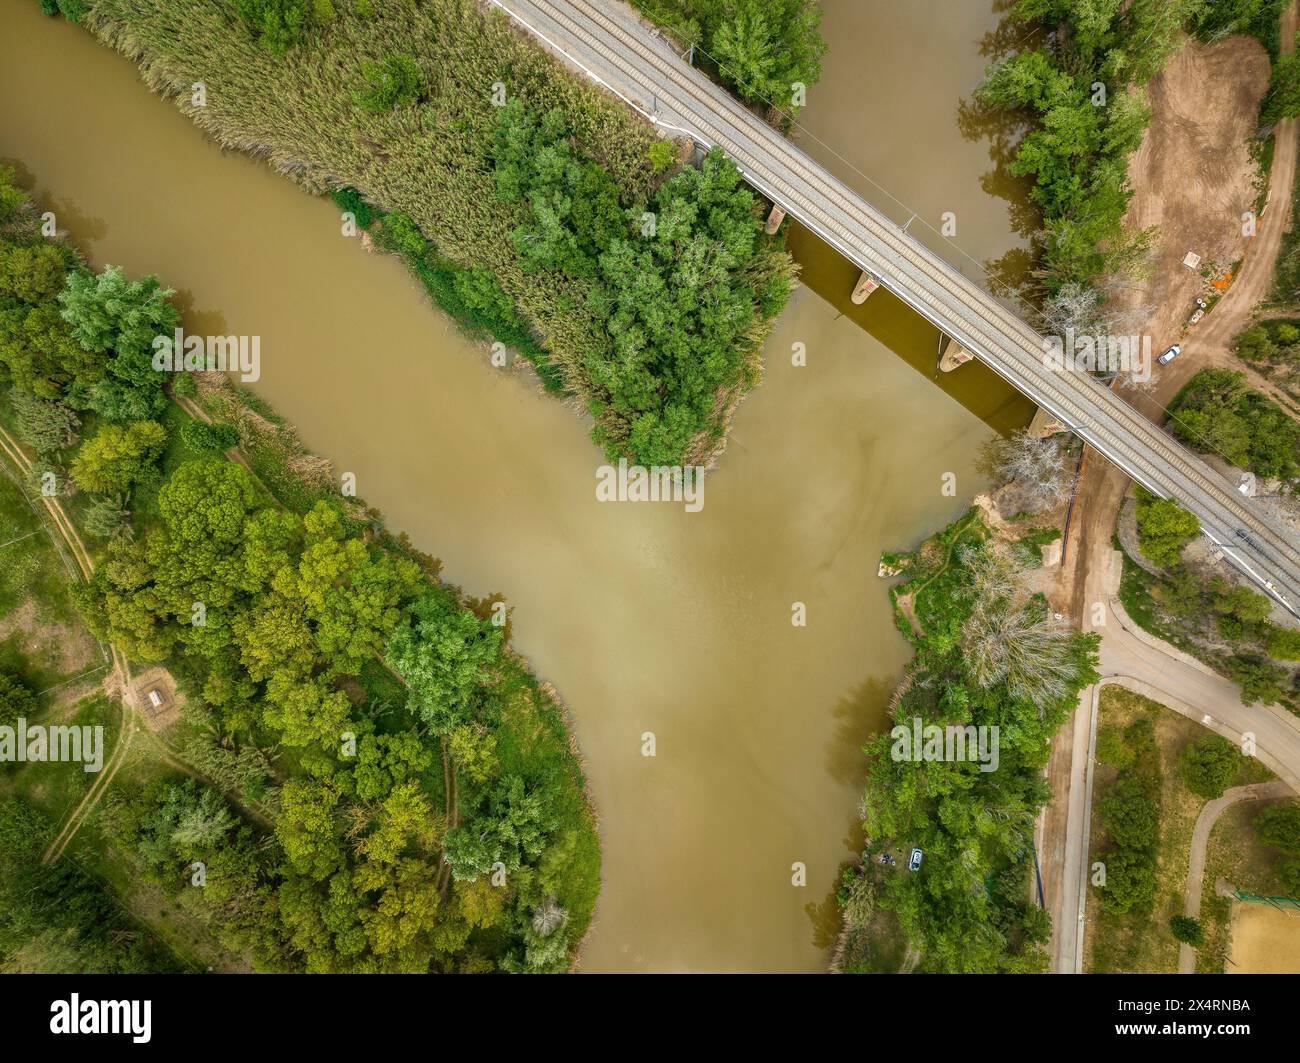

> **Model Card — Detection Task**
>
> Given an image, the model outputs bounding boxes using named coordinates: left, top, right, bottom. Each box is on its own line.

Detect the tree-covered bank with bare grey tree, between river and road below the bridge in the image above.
left=836, top=496, right=1097, bottom=973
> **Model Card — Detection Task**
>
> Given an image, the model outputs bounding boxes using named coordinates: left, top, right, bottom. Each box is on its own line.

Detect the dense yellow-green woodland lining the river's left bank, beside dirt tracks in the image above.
left=0, top=159, right=599, bottom=972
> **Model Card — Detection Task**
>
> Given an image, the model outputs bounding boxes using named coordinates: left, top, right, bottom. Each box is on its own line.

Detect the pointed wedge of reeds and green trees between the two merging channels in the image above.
left=63, top=0, right=793, bottom=465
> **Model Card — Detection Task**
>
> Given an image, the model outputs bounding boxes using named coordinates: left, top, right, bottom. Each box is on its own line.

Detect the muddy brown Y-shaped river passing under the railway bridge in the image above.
left=0, top=0, right=1030, bottom=971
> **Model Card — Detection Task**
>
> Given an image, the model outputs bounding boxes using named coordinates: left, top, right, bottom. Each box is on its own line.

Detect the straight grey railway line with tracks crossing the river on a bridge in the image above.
left=489, top=0, right=1300, bottom=615
